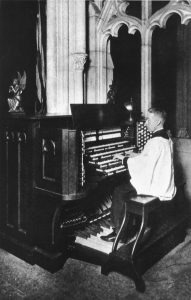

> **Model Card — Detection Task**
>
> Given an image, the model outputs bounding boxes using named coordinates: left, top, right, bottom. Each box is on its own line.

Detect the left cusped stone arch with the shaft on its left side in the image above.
left=97, top=0, right=141, bottom=102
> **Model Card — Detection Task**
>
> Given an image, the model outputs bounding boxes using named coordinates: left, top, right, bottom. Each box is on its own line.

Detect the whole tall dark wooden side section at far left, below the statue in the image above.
left=0, top=118, right=38, bottom=240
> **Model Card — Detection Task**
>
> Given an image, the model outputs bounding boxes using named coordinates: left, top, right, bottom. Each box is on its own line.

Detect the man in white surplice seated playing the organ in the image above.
left=101, top=107, right=176, bottom=242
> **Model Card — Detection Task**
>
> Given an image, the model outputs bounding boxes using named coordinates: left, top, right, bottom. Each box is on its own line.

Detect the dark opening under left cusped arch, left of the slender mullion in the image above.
left=110, top=25, right=141, bottom=113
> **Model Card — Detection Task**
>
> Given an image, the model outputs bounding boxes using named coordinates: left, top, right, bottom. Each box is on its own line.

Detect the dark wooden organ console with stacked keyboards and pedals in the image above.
left=0, top=104, right=186, bottom=290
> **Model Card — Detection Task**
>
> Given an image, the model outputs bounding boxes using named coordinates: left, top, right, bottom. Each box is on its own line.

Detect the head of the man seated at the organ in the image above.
left=145, top=107, right=166, bottom=132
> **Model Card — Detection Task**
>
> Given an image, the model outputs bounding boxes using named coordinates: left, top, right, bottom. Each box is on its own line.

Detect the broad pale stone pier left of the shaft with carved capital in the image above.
left=47, top=0, right=69, bottom=114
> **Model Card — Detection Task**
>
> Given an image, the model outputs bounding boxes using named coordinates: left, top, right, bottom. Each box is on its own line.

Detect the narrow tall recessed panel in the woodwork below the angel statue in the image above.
left=5, top=131, right=27, bottom=232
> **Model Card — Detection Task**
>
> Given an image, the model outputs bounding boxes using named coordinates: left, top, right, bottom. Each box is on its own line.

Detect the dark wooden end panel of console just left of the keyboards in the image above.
left=36, top=128, right=82, bottom=199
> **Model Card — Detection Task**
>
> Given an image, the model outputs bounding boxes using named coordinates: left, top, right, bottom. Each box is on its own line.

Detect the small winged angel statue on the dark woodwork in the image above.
left=7, top=71, right=27, bottom=113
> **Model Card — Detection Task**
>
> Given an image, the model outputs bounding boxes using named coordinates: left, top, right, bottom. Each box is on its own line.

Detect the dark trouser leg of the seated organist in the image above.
left=111, top=182, right=137, bottom=233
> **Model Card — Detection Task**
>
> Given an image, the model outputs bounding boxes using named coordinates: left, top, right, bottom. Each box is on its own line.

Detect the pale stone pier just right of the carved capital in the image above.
left=87, top=1, right=113, bottom=103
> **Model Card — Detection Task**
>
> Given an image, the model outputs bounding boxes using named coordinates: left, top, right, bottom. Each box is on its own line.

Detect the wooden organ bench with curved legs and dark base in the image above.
left=102, top=185, right=187, bottom=292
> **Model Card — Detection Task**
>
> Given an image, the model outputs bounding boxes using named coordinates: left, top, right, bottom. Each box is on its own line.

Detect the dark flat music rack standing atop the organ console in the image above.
left=71, top=104, right=129, bottom=130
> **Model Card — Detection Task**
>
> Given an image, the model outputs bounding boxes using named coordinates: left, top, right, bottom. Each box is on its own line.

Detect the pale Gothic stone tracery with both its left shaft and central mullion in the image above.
left=88, top=0, right=191, bottom=115
